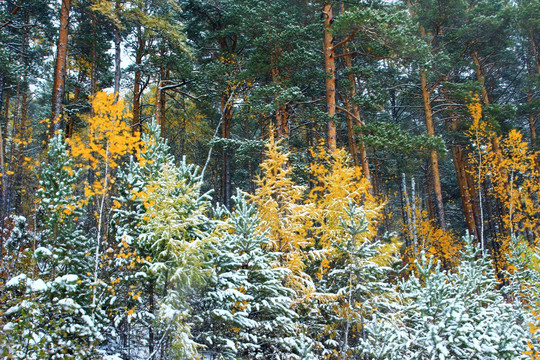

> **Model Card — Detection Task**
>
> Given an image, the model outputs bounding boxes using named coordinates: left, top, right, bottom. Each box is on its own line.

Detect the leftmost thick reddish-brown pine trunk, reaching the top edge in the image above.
left=49, top=0, right=71, bottom=137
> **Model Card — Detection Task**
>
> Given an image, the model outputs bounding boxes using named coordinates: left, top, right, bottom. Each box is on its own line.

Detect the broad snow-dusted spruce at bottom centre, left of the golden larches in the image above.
left=196, top=191, right=308, bottom=359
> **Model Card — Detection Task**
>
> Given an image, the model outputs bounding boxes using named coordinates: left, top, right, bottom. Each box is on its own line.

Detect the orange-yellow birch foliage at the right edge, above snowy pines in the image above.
left=467, top=96, right=540, bottom=265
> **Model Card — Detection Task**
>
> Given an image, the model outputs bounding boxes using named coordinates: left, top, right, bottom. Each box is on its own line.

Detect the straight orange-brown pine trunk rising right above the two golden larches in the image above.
left=322, top=3, right=337, bottom=153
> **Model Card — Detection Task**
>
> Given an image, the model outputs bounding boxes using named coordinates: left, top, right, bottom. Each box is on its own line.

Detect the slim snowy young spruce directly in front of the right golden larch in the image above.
left=318, top=201, right=397, bottom=359
